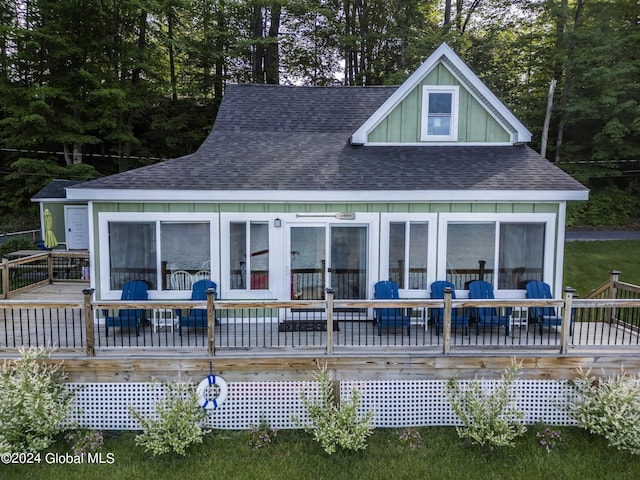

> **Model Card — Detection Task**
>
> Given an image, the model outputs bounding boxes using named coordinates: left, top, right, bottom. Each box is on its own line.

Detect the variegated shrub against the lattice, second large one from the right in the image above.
left=445, top=363, right=527, bottom=450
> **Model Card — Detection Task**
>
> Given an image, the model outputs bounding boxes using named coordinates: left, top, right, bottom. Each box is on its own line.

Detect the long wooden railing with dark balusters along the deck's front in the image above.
left=0, top=274, right=640, bottom=356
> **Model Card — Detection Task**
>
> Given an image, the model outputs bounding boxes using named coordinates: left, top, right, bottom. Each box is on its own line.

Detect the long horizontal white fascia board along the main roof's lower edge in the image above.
left=67, top=189, right=589, bottom=204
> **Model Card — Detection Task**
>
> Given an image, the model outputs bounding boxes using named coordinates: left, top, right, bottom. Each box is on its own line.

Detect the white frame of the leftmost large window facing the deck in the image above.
left=97, top=212, right=220, bottom=300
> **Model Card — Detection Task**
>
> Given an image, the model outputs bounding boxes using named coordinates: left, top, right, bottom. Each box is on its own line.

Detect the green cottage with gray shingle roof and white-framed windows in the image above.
left=65, top=44, right=588, bottom=300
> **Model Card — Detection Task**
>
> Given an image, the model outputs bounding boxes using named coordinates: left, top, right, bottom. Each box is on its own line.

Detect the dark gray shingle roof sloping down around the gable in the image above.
left=69, top=85, right=586, bottom=195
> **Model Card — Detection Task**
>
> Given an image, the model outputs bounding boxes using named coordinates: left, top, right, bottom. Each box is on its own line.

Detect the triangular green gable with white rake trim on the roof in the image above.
left=351, top=43, right=531, bottom=145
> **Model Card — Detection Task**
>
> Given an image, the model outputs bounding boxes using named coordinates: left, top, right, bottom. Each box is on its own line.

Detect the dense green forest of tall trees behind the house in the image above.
left=0, top=0, right=640, bottom=232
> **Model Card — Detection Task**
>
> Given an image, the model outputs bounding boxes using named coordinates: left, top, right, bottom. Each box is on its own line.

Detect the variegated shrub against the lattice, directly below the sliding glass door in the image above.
left=300, top=364, right=373, bottom=455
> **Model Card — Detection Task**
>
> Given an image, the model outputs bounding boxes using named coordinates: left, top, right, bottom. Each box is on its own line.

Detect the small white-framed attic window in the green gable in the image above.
left=421, top=85, right=458, bottom=141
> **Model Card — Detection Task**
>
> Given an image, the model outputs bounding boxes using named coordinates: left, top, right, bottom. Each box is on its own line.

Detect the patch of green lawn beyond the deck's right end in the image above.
left=562, top=240, right=640, bottom=298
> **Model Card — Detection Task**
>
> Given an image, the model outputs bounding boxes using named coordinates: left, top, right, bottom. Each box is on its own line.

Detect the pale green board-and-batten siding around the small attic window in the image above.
left=368, top=64, right=511, bottom=143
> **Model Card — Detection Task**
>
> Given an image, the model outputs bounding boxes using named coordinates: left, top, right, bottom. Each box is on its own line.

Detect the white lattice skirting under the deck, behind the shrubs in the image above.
left=69, top=380, right=575, bottom=430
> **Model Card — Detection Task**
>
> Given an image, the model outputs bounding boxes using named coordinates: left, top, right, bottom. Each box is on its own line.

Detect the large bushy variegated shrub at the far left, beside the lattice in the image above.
left=0, top=347, right=74, bottom=452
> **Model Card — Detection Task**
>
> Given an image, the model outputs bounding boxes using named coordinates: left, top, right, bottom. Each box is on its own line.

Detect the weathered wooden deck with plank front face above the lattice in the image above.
left=0, top=282, right=640, bottom=382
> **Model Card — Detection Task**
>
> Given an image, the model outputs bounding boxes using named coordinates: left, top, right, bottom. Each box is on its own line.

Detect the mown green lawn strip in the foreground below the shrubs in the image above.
left=5, top=426, right=640, bottom=480
